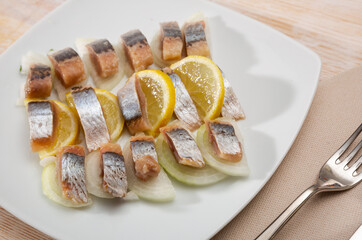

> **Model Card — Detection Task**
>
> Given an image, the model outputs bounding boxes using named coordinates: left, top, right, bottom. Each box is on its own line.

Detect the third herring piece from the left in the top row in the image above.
left=87, top=39, right=119, bottom=78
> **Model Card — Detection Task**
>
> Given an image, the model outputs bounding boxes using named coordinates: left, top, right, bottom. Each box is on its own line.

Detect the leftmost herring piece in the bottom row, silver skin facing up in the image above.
left=60, top=152, right=88, bottom=203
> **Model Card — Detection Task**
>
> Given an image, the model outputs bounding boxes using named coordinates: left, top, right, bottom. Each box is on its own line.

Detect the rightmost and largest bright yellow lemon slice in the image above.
left=170, top=56, right=225, bottom=120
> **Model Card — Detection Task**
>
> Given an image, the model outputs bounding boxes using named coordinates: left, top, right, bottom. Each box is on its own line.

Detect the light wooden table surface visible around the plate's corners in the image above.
left=0, top=0, right=362, bottom=239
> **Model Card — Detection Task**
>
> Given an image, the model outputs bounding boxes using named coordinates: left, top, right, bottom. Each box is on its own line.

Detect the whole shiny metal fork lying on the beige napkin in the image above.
left=256, top=124, right=362, bottom=240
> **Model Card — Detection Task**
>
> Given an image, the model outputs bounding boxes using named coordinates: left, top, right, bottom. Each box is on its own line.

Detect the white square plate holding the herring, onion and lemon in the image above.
left=0, top=0, right=321, bottom=239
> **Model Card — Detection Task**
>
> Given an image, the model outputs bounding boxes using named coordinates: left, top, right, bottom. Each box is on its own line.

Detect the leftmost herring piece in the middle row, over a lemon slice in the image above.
left=28, top=101, right=56, bottom=152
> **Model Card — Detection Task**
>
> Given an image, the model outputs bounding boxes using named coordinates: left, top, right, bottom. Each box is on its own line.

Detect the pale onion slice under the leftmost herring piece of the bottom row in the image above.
left=41, top=163, right=92, bottom=207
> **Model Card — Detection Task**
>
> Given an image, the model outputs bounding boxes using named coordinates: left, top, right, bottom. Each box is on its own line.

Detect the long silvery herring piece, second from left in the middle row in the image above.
left=71, top=87, right=110, bottom=152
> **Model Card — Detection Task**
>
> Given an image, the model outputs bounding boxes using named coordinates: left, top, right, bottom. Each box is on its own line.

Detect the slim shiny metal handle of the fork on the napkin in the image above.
left=255, top=185, right=318, bottom=240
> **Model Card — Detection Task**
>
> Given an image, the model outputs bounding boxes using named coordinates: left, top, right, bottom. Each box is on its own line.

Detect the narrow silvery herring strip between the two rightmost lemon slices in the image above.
left=162, top=68, right=202, bottom=131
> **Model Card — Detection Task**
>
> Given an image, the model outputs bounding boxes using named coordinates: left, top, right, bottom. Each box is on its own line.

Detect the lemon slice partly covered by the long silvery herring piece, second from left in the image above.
left=66, top=88, right=124, bottom=142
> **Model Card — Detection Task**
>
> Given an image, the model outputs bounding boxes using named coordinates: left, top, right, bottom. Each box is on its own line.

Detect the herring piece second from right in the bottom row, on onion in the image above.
left=160, top=124, right=205, bottom=168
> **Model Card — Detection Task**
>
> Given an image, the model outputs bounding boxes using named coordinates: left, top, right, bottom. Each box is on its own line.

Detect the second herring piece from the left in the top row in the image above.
left=48, top=48, right=86, bottom=88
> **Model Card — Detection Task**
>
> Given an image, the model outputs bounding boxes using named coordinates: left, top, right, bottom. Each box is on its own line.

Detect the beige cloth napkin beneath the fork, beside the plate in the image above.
left=214, top=67, right=362, bottom=240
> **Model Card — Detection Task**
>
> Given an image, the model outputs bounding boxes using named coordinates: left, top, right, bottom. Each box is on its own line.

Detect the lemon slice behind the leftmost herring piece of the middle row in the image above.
left=24, top=99, right=78, bottom=159
